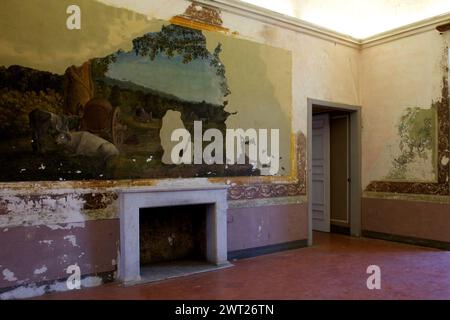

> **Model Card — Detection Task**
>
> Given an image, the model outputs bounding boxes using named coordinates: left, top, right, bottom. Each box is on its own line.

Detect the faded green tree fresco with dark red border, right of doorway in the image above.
left=366, top=77, right=450, bottom=195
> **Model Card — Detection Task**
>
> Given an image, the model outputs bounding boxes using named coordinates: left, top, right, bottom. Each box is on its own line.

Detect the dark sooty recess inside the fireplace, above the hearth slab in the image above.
left=139, top=205, right=207, bottom=268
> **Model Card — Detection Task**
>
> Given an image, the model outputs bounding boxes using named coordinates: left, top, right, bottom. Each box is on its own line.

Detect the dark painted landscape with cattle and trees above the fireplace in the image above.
left=0, top=25, right=260, bottom=181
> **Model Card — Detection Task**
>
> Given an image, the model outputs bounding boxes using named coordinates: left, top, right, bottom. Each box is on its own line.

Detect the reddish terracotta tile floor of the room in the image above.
left=37, top=233, right=450, bottom=300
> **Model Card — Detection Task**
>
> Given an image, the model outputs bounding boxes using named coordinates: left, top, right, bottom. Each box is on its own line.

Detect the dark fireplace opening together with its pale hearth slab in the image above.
left=139, top=204, right=229, bottom=282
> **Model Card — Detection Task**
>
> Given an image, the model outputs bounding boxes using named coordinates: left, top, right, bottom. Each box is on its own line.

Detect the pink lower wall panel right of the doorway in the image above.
left=362, top=198, right=450, bottom=242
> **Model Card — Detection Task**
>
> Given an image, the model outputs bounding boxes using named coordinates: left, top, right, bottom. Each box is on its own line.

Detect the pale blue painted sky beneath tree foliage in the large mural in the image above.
left=106, top=52, right=223, bottom=105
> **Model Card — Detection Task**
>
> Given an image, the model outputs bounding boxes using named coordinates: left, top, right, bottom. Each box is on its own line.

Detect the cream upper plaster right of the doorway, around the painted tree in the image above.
left=361, top=30, right=447, bottom=189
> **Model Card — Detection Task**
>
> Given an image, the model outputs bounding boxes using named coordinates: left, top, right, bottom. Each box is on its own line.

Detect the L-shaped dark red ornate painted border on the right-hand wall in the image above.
left=365, top=78, right=450, bottom=196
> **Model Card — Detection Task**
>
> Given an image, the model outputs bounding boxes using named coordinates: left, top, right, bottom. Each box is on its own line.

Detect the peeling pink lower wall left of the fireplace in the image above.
left=0, top=220, right=119, bottom=288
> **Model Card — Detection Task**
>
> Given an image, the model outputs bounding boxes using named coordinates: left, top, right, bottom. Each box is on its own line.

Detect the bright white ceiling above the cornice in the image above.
left=241, top=0, right=450, bottom=39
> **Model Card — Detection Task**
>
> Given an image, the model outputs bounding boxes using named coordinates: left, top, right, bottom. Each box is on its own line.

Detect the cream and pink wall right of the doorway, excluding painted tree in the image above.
left=361, top=30, right=450, bottom=243
